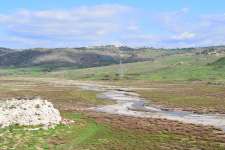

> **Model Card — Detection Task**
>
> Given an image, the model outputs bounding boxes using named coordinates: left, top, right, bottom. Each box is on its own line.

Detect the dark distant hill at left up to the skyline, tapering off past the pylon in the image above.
left=0, top=47, right=156, bottom=69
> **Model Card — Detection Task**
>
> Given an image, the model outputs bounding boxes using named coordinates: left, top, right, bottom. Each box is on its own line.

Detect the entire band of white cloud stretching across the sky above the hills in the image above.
left=0, top=5, right=225, bottom=47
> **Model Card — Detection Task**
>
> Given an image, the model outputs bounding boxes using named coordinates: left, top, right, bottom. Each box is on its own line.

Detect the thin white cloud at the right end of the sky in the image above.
left=152, top=8, right=225, bottom=47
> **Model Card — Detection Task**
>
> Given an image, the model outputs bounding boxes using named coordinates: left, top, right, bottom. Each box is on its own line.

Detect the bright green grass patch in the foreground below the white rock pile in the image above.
left=0, top=114, right=104, bottom=150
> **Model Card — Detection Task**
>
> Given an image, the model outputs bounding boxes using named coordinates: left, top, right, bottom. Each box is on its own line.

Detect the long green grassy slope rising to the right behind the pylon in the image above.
left=50, top=55, right=225, bottom=81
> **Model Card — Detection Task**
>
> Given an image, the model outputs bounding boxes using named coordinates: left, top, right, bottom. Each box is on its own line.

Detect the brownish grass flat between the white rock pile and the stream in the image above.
left=0, top=78, right=111, bottom=110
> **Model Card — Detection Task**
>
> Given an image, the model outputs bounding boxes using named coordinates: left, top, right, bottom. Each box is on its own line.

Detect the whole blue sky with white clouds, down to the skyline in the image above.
left=0, top=0, right=225, bottom=48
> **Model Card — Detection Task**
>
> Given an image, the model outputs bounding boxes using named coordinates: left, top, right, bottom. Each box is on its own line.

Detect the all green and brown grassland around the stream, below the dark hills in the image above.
left=0, top=55, right=225, bottom=150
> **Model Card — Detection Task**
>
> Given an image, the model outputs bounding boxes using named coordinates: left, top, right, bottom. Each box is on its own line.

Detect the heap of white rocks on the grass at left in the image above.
left=0, top=98, right=62, bottom=128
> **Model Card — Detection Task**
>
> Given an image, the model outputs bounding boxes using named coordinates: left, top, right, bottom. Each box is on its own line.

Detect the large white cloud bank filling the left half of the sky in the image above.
left=0, top=5, right=132, bottom=46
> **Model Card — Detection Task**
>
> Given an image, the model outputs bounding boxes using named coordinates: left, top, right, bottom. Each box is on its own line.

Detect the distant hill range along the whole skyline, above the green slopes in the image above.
left=0, top=45, right=225, bottom=69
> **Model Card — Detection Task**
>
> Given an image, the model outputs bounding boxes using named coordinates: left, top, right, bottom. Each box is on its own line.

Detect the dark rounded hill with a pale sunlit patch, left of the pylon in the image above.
left=0, top=50, right=116, bottom=68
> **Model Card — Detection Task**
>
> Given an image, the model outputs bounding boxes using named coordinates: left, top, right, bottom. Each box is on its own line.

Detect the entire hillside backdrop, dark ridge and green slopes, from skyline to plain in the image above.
left=0, top=45, right=225, bottom=81
